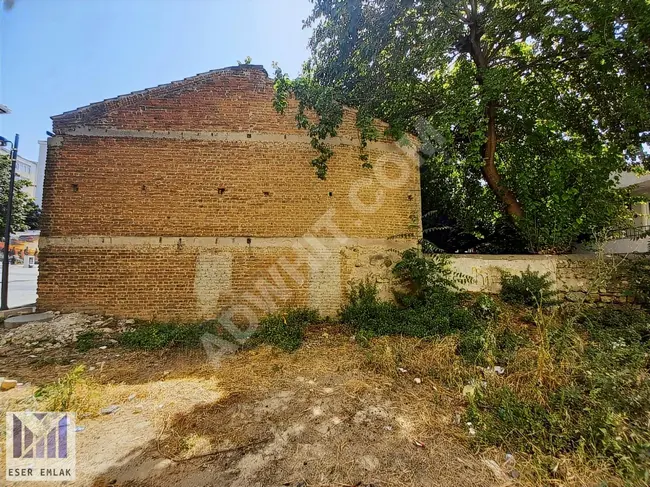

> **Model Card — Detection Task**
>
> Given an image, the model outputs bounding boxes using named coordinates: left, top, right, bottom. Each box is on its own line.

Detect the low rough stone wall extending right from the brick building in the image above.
left=451, top=255, right=642, bottom=303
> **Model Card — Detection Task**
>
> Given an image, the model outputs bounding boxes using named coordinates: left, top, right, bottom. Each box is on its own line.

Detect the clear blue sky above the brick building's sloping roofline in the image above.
left=0, top=0, right=311, bottom=160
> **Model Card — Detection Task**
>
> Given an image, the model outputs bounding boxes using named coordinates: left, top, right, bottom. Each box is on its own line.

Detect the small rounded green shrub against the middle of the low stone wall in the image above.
left=500, top=267, right=556, bottom=306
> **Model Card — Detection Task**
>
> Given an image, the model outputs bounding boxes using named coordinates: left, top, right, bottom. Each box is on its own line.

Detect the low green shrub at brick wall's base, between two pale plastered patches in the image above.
left=249, top=308, right=321, bottom=352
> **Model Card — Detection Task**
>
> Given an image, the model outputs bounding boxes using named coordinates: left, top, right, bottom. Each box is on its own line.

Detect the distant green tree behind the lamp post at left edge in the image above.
left=0, top=155, right=40, bottom=234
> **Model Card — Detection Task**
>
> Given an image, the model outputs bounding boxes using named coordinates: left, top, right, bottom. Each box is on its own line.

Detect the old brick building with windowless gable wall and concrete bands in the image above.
left=38, top=65, right=421, bottom=320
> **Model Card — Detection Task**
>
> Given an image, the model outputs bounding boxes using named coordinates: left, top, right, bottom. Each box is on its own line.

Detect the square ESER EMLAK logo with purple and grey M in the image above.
left=6, top=412, right=76, bottom=482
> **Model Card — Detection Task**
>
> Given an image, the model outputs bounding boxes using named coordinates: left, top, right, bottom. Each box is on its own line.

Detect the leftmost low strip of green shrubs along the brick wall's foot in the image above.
left=118, top=322, right=223, bottom=350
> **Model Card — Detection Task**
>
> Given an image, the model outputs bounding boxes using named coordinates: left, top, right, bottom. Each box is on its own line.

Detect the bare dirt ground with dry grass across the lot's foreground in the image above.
left=0, top=327, right=521, bottom=487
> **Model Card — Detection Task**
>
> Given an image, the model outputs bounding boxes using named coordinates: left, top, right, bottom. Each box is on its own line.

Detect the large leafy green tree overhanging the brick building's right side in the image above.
left=276, top=0, right=650, bottom=255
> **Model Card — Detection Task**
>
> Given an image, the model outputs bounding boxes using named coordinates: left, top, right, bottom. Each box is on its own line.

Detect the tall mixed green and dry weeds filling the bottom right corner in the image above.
left=467, top=308, right=650, bottom=485
